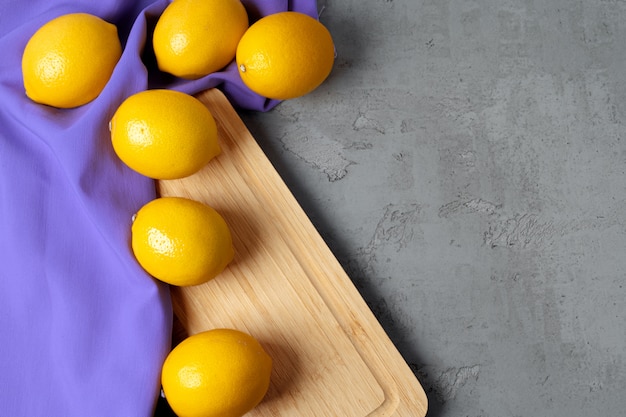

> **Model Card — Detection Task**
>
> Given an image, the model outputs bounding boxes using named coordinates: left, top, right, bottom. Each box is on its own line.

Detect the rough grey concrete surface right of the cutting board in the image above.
left=236, top=0, right=626, bottom=417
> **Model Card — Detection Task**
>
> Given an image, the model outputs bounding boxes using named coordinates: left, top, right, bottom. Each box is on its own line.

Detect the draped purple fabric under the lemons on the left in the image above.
left=0, top=0, right=316, bottom=417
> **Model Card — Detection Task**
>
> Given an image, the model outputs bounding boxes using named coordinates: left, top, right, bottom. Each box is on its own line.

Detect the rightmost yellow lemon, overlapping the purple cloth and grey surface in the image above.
left=236, top=12, right=335, bottom=100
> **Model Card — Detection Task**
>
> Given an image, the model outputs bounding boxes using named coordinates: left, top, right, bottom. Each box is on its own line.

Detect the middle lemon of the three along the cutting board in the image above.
left=131, top=197, right=234, bottom=286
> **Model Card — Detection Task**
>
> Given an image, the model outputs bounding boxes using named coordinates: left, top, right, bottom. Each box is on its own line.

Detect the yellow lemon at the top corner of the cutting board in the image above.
left=110, top=90, right=220, bottom=179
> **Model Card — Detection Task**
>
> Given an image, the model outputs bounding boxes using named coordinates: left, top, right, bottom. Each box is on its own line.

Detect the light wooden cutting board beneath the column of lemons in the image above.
left=157, top=89, right=427, bottom=417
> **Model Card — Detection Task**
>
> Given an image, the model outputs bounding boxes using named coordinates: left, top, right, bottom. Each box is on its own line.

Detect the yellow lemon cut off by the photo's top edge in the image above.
left=152, top=0, right=248, bottom=79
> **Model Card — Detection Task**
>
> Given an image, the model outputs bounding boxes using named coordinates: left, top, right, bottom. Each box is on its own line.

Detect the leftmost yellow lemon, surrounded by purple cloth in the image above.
left=22, top=13, right=122, bottom=108
